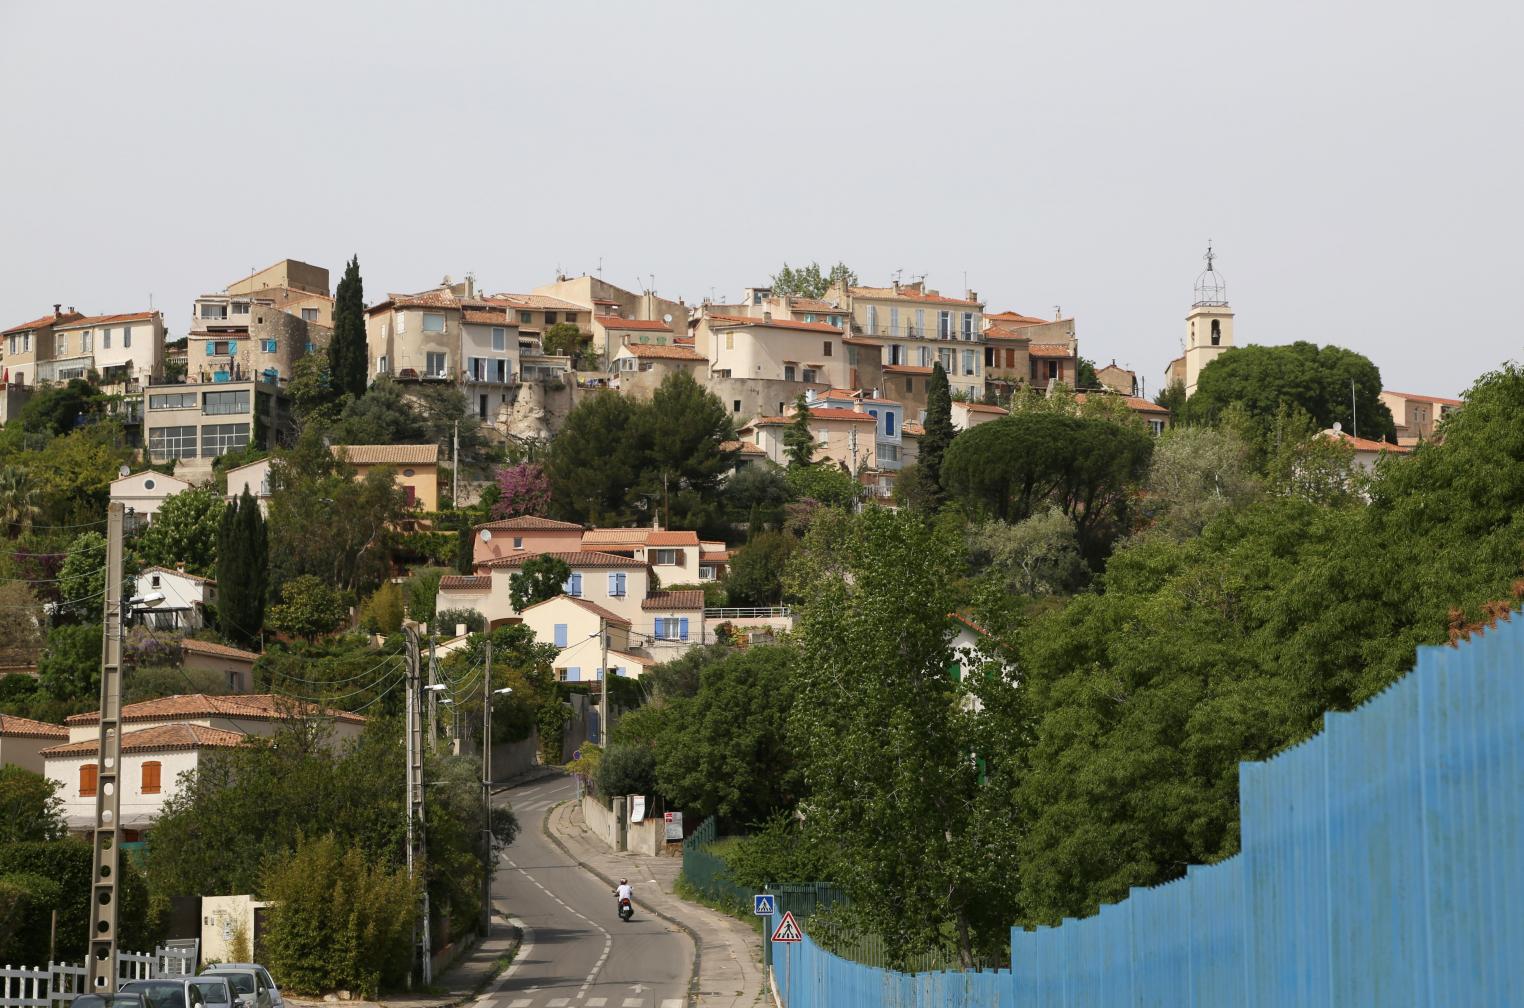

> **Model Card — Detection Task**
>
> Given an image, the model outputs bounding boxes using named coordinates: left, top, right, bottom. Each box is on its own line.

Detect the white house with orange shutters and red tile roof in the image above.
left=41, top=694, right=366, bottom=840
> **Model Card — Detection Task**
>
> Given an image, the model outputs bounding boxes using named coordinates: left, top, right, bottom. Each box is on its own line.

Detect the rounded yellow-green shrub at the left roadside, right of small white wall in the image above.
left=261, top=836, right=416, bottom=999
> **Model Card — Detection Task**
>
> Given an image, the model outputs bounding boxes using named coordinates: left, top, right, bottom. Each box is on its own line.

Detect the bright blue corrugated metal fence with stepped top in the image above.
left=773, top=619, right=1524, bottom=1008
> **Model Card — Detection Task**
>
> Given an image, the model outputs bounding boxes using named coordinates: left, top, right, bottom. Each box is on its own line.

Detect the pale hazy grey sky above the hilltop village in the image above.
left=0, top=0, right=1524, bottom=395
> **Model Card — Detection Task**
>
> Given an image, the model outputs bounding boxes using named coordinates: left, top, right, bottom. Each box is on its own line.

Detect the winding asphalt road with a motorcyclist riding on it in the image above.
left=479, top=778, right=693, bottom=1008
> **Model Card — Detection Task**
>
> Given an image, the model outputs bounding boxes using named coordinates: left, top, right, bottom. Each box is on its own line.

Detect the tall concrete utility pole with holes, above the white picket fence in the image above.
left=85, top=502, right=125, bottom=994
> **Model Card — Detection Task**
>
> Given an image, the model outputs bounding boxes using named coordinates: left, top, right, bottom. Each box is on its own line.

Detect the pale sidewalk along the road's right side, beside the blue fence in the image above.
left=544, top=801, right=771, bottom=1008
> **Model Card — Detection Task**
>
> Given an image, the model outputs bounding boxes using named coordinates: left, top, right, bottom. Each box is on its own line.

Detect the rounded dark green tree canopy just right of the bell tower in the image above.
left=1186, top=340, right=1396, bottom=441
